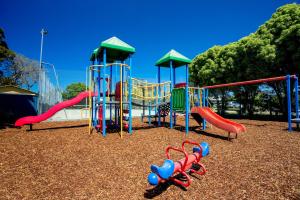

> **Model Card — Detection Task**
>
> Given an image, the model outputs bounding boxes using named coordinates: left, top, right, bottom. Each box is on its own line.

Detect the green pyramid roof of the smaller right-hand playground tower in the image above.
left=155, top=49, right=192, bottom=67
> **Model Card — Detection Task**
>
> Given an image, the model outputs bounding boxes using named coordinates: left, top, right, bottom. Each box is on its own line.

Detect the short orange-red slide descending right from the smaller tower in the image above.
left=191, top=107, right=246, bottom=133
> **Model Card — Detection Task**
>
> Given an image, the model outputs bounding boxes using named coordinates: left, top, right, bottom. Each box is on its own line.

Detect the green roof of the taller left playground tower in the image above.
left=96, top=37, right=135, bottom=62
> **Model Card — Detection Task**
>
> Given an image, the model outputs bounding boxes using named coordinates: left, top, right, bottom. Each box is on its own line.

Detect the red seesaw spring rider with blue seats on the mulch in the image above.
left=148, top=140, right=209, bottom=187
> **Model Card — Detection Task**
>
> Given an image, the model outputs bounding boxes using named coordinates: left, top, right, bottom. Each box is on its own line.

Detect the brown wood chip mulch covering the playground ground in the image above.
left=0, top=118, right=300, bottom=200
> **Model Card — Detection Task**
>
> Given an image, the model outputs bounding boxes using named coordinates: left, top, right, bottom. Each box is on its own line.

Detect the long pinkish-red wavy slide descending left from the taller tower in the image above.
left=15, top=91, right=94, bottom=126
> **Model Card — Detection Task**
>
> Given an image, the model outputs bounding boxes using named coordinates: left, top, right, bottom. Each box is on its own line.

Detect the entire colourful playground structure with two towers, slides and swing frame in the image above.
left=15, top=37, right=300, bottom=138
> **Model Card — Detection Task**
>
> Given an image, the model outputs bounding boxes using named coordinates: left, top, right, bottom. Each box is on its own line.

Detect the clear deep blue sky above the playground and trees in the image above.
left=0, top=0, right=299, bottom=88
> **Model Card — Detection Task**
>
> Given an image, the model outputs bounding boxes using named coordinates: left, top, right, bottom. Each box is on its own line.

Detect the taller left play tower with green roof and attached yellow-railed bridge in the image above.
left=89, top=37, right=170, bottom=137
